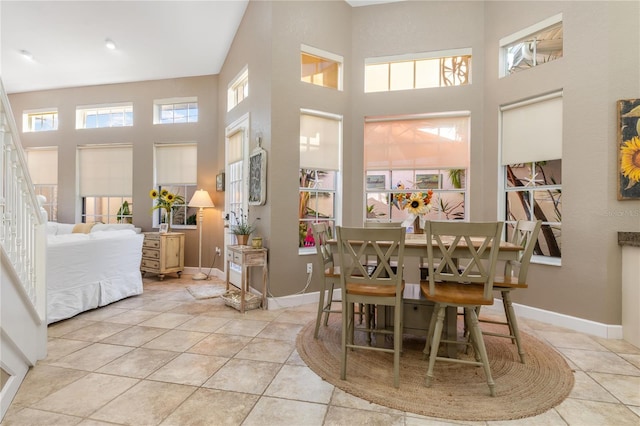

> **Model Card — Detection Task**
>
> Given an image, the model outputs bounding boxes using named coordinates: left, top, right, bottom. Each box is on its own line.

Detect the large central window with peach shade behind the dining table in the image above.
left=364, top=113, right=469, bottom=222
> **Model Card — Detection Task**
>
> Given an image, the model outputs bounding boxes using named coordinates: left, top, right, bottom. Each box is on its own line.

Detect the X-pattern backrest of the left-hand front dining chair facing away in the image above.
left=336, top=226, right=406, bottom=289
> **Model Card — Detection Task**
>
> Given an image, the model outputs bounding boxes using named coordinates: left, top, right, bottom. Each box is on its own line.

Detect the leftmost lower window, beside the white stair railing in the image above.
left=25, top=147, right=58, bottom=222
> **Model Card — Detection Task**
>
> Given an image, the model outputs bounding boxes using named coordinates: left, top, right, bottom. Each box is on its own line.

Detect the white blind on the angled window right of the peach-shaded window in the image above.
left=501, top=92, right=562, bottom=165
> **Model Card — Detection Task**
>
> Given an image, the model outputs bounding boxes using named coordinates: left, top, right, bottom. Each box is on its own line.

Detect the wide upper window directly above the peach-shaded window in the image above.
left=364, top=49, right=471, bottom=93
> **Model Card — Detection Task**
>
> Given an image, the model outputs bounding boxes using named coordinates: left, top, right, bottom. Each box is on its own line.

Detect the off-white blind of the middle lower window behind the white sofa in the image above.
left=78, top=145, right=133, bottom=197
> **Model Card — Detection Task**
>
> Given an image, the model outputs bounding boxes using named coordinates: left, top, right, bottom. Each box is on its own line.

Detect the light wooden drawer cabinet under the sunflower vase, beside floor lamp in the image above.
left=140, top=232, right=184, bottom=281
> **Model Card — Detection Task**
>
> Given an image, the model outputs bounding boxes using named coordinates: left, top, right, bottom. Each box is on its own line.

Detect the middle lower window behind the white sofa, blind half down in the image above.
left=77, top=145, right=133, bottom=223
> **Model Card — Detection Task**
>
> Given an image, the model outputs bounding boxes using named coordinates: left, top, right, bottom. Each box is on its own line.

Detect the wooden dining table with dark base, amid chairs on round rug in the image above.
left=329, top=233, right=524, bottom=357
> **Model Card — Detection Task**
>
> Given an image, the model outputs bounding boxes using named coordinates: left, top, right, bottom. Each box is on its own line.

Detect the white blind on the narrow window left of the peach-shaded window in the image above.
left=300, top=112, right=341, bottom=171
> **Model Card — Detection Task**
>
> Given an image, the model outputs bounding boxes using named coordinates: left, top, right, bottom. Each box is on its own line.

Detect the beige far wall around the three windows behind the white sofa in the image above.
left=9, top=76, right=224, bottom=267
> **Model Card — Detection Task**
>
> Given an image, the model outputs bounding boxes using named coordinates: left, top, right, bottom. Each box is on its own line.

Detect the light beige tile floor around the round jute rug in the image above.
left=2, top=275, right=640, bottom=426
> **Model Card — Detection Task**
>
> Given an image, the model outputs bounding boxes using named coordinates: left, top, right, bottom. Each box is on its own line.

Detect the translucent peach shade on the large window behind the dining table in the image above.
left=364, top=115, right=469, bottom=170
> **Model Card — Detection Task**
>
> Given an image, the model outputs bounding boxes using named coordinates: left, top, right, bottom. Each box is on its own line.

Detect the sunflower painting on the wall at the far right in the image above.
left=618, top=99, right=640, bottom=200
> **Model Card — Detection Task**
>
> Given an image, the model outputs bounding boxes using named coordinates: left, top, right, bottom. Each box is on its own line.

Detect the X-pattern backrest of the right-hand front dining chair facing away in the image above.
left=425, top=221, right=503, bottom=300
